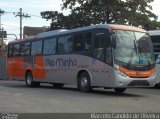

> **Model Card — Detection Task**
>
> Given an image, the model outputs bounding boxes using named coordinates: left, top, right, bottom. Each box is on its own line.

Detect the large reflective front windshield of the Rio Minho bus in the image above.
left=114, top=30, right=155, bottom=66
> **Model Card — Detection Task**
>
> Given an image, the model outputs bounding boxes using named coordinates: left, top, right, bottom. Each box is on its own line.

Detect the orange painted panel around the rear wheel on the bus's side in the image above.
left=7, top=56, right=46, bottom=79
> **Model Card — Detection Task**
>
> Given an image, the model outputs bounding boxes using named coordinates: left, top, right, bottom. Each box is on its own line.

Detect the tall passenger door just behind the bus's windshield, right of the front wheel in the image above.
left=92, top=31, right=105, bottom=86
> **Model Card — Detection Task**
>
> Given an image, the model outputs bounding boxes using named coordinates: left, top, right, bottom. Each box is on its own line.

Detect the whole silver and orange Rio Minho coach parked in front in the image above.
left=7, top=24, right=156, bottom=93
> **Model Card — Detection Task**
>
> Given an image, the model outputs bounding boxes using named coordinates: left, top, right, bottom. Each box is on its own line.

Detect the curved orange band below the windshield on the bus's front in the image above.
left=119, top=67, right=156, bottom=78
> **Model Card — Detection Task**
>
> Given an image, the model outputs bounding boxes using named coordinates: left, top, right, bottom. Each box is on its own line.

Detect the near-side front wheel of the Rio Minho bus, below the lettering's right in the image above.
left=77, top=72, right=92, bottom=93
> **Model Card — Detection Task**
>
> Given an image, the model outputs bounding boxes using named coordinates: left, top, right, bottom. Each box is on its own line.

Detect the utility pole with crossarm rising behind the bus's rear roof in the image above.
left=16, top=8, right=31, bottom=39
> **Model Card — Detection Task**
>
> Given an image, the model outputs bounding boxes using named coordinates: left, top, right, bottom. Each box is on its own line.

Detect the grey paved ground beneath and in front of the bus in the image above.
left=0, top=80, right=160, bottom=113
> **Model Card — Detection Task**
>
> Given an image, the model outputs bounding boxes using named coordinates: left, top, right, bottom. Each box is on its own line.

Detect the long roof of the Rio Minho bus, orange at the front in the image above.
left=9, top=24, right=147, bottom=43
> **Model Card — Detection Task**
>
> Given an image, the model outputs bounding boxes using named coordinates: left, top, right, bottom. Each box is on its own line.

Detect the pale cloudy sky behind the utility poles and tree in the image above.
left=0, top=0, right=160, bottom=40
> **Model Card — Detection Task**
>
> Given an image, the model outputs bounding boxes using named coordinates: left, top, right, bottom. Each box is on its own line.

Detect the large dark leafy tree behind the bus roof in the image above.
left=41, top=0, right=158, bottom=30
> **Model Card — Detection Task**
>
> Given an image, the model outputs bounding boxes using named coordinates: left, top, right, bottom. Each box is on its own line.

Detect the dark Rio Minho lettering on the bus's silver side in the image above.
left=46, top=58, right=77, bottom=67
